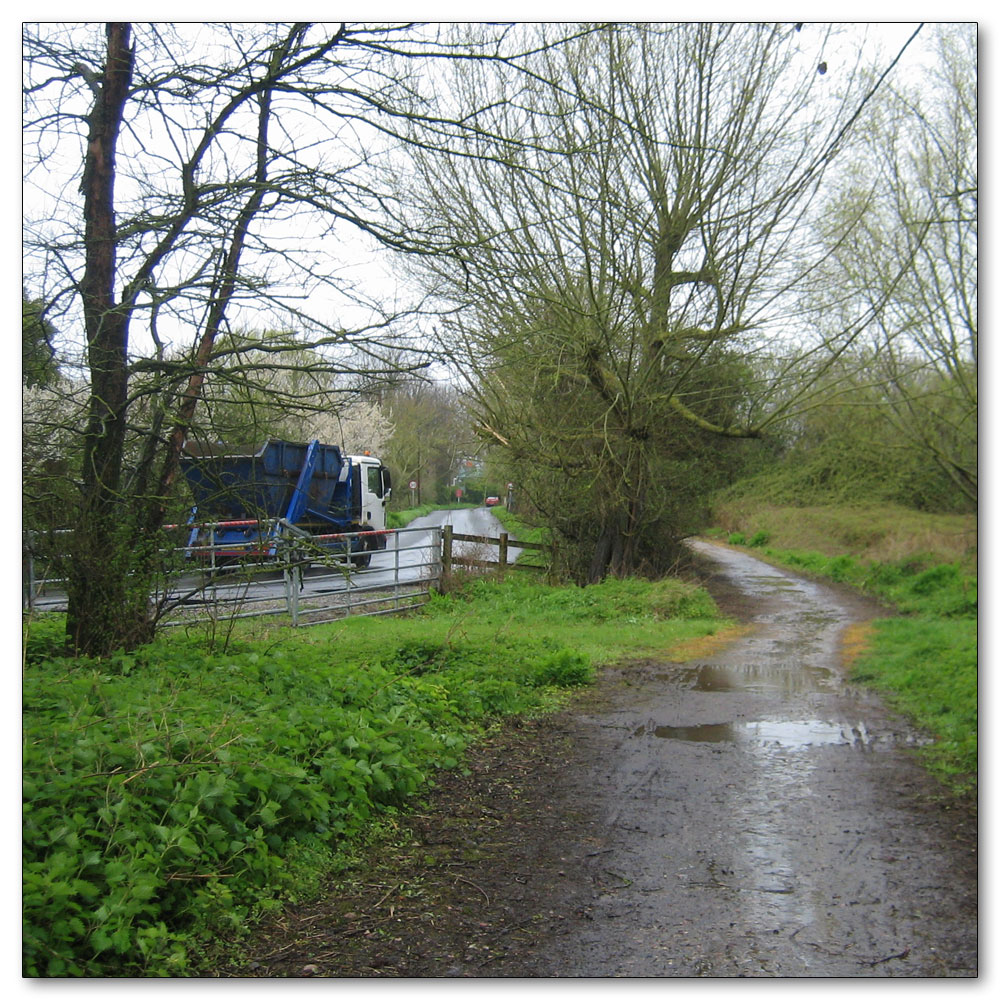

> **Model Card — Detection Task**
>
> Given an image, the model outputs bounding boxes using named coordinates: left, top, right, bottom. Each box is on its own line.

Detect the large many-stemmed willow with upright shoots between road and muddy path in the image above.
left=402, top=23, right=916, bottom=579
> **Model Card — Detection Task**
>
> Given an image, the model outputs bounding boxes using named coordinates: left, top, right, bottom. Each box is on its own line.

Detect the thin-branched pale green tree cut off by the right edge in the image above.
left=821, top=24, right=979, bottom=506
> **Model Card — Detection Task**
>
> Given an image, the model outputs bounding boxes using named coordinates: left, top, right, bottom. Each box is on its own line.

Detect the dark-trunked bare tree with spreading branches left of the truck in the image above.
left=23, top=23, right=588, bottom=654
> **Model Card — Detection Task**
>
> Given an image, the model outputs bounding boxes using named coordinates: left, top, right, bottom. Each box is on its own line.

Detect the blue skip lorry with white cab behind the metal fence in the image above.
left=181, top=439, right=392, bottom=567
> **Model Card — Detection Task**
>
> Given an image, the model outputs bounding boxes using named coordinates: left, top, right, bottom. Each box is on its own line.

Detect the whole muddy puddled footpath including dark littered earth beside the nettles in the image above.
left=229, top=543, right=978, bottom=977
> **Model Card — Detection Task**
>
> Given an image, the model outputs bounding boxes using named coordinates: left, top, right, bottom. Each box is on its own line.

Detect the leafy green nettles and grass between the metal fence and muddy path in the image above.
left=23, top=579, right=723, bottom=976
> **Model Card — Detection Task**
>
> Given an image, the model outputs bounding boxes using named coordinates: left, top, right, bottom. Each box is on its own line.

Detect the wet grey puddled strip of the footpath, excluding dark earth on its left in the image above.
left=534, top=542, right=977, bottom=976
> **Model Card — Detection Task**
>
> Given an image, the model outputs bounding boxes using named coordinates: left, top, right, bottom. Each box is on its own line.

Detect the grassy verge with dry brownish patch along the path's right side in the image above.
left=716, top=499, right=978, bottom=792
